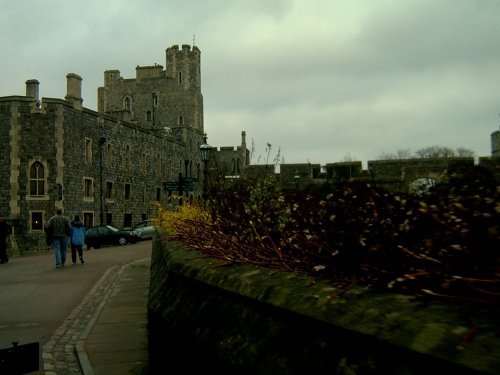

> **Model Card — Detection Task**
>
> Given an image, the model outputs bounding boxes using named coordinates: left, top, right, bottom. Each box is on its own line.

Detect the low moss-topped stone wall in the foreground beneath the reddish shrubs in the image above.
left=148, top=237, right=500, bottom=375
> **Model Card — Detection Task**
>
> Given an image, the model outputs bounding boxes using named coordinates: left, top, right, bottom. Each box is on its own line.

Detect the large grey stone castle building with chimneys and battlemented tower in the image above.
left=0, top=45, right=249, bottom=253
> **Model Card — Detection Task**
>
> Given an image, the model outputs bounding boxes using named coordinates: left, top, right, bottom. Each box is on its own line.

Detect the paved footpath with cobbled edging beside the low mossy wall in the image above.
left=42, top=257, right=151, bottom=375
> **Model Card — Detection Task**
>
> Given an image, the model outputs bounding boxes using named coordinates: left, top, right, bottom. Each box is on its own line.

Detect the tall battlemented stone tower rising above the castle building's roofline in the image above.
left=97, top=44, right=204, bottom=182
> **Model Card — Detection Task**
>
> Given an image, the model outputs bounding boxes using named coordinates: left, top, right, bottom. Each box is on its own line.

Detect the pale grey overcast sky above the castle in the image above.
left=0, top=0, right=500, bottom=165
